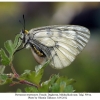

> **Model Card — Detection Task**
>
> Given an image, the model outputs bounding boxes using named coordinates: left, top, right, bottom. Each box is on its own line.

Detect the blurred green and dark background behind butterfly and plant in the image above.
left=0, top=2, right=100, bottom=92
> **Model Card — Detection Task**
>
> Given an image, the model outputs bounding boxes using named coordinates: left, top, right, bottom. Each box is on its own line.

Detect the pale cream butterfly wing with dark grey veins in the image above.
left=29, top=25, right=90, bottom=69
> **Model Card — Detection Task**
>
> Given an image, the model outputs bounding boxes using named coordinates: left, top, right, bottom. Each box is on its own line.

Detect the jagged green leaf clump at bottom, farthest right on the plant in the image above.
left=49, top=75, right=74, bottom=92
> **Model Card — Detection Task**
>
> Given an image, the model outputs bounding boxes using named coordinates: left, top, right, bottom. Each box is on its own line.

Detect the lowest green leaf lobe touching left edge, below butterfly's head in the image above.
left=0, top=48, right=10, bottom=66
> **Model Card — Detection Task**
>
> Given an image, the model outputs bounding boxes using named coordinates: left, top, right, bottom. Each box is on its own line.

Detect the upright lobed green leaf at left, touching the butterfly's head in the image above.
left=0, top=34, right=22, bottom=65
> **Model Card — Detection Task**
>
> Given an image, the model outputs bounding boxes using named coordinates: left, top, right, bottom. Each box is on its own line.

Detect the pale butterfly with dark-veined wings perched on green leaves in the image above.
left=15, top=15, right=90, bottom=69
